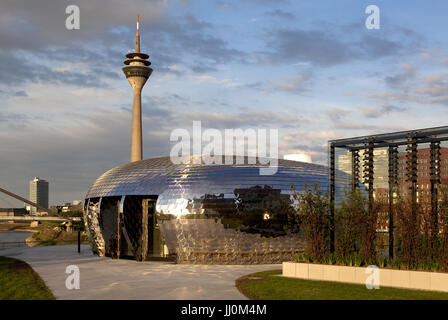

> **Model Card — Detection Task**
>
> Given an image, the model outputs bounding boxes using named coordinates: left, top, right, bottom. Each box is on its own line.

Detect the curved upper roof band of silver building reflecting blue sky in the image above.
left=86, top=157, right=328, bottom=198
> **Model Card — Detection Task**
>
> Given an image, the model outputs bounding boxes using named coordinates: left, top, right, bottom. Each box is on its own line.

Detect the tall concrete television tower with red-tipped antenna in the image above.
left=123, top=16, right=152, bottom=162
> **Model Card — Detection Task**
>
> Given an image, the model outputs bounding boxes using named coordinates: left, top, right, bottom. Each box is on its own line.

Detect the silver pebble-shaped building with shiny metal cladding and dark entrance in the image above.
left=84, top=157, right=328, bottom=264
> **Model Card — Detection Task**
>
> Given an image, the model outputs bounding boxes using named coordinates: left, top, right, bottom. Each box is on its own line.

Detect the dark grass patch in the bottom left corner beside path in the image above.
left=0, top=257, right=54, bottom=300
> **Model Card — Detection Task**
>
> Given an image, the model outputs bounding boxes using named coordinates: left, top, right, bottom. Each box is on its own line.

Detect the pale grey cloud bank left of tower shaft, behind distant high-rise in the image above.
left=0, top=110, right=128, bottom=204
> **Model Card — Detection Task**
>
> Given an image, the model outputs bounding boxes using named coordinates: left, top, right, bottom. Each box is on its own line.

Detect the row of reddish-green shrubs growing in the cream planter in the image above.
left=293, top=185, right=448, bottom=272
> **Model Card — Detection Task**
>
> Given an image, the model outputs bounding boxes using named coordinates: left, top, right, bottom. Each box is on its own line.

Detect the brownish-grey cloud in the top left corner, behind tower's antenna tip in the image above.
left=0, top=0, right=167, bottom=50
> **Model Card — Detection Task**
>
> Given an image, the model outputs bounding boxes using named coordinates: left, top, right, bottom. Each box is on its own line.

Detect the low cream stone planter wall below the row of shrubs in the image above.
left=283, top=262, right=448, bottom=292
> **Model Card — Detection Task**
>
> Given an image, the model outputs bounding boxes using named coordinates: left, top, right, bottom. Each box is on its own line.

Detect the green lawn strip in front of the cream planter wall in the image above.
left=236, top=270, right=448, bottom=300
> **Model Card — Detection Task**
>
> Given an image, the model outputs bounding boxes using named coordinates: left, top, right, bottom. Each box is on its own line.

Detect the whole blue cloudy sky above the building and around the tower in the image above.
left=0, top=0, right=448, bottom=207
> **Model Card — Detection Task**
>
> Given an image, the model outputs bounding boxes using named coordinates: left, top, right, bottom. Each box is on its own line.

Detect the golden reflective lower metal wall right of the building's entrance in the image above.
left=158, top=186, right=304, bottom=264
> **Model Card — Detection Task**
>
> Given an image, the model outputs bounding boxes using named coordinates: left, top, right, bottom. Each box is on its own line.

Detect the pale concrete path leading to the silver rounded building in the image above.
left=0, top=245, right=281, bottom=300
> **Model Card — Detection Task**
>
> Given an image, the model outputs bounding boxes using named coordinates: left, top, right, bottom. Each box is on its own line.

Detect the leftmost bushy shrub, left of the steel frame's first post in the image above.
left=294, top=184, right=330, bottom=261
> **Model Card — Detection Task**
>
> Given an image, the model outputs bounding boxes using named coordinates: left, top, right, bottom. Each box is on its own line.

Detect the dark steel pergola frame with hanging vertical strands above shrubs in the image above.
left=328, top=126, right=448, bottom=257
